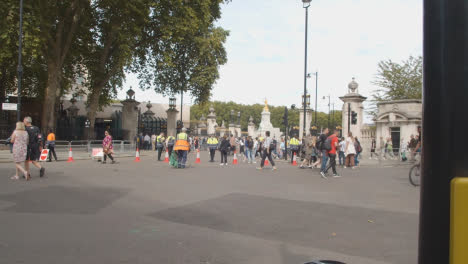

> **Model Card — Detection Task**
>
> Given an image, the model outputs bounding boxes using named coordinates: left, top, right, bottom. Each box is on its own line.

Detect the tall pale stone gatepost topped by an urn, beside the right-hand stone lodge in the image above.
left=340, top=78, right=367, bottom=139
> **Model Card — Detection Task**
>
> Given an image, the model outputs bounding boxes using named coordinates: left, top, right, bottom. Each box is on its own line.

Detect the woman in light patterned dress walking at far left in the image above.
left=11, top=122, right=31, bottom=180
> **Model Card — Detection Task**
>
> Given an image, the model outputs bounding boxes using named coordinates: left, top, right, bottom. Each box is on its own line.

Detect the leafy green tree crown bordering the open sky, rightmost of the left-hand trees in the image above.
left=139, top=0, right=228, bottom=102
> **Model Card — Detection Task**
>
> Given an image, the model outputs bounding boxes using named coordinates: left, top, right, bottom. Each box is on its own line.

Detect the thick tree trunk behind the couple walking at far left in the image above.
left=41, top=62, right=62, bottom=131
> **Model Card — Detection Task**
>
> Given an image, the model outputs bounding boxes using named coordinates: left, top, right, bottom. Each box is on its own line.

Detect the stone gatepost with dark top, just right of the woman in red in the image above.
left=121, top=88, right=140, bottom=142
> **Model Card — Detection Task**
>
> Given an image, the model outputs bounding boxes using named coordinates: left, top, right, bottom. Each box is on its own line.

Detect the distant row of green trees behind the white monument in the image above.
left=190, top=101, right=341, bottom=131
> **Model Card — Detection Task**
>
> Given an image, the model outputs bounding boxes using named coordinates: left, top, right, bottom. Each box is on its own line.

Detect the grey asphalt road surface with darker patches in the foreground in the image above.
left=0, top=152, right=419, bottom=264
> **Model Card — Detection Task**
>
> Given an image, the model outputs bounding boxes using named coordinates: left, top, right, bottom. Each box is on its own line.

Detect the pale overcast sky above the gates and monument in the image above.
left=118, top=0, right=423, bottom=121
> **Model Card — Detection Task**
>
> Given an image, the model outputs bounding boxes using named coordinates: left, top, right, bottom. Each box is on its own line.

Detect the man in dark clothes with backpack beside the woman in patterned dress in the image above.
left=23, top=116, right=45, bottom=177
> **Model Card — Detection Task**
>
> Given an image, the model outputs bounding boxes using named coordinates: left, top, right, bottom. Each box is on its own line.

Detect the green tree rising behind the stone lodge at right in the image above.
left=369, top=56, right=422, bottom=116
